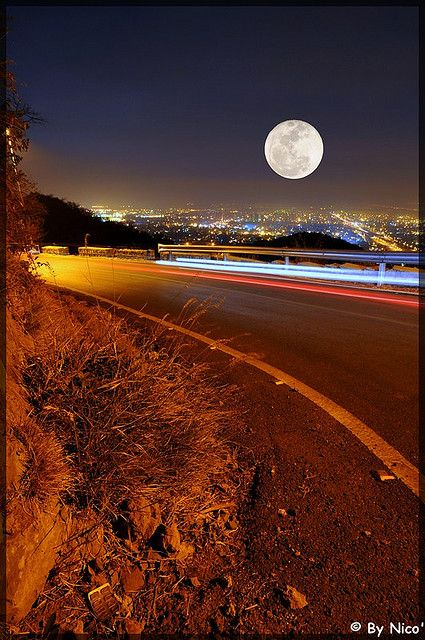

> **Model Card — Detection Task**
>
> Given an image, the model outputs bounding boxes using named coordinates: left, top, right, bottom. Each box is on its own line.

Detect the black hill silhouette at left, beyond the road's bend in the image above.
left=36, top=193, right=158, bottom=249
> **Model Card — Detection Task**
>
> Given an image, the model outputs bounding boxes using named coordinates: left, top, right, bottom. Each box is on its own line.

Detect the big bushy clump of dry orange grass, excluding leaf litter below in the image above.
left=9, top=250, right=237, bottom=517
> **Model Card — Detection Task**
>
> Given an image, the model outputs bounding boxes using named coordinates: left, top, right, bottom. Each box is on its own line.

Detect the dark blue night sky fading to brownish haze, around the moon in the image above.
left=7, top=6, right=418, bottom=208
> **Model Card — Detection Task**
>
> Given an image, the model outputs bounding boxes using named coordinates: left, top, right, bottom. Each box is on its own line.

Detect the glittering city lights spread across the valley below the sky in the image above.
left=91, top=204, right=419, bottom=251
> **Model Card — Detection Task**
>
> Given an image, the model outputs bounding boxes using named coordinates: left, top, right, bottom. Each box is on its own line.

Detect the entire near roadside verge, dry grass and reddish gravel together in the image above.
left=8, top=254, right=419, bottom=638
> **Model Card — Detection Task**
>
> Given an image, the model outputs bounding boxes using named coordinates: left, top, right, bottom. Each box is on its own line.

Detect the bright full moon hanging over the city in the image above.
left=264, top=120, right=323, bottom=180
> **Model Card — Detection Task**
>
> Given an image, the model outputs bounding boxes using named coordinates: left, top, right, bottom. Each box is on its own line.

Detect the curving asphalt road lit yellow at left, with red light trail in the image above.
left=35, top=255, right=419, bottom=465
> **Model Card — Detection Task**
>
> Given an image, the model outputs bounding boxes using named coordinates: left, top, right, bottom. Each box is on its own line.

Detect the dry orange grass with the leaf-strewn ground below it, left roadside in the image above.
left=8, top=251, right=248, bottom=637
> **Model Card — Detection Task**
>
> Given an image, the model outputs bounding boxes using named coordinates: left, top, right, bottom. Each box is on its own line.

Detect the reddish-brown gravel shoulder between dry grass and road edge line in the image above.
left=116, top=304, right=419, bottom=634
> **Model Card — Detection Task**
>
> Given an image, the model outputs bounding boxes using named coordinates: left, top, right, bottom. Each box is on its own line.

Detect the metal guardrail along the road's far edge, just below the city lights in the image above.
left=158, top=244, right=419, bottom=266
